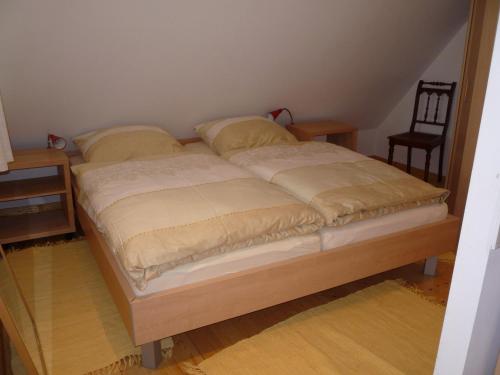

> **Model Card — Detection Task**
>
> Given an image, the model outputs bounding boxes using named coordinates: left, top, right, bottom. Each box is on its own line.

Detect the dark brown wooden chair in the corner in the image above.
left=387, top=80, right=456, bottom=182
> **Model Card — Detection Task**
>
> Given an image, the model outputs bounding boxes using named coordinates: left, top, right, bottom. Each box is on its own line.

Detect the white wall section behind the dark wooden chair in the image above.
left=359, top=23, right=467, bottom=173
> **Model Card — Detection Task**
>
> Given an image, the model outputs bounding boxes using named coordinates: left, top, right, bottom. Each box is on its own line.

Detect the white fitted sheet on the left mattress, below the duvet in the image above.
left=132, top=234, right=321, bottom=297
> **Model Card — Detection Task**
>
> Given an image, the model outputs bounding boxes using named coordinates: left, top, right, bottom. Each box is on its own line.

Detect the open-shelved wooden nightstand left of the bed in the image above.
left=0, top=149, right=75, bottom=244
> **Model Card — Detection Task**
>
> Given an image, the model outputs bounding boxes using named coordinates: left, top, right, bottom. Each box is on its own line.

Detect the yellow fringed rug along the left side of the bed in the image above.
left=0, top=241, right=173, bottom=375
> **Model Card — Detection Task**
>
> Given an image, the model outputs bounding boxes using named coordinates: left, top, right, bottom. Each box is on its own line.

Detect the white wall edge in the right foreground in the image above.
left=435, top=15, right=500, bottom=375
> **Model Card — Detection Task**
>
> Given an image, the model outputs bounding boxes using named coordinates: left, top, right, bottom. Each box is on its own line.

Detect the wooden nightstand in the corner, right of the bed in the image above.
left=286, top=121, right=358, bottom=151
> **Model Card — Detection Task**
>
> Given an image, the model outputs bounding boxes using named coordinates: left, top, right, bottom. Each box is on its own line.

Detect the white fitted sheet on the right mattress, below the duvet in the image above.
left=320, top=203, right=448, bottom=250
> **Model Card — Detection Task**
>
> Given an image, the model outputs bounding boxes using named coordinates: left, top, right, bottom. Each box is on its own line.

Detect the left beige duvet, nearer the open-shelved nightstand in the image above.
left=73, top=152, right=324, bottom=289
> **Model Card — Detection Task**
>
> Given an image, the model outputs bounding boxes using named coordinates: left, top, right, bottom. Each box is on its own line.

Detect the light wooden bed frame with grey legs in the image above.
left=73, top=138, right=459, bottom=368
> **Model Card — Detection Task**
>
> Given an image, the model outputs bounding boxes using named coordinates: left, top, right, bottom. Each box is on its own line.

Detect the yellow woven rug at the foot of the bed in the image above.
left=188, top=281, right=444, bottom=375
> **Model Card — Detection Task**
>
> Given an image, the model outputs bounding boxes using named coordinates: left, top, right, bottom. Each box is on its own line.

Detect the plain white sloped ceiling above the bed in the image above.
left=0, top=0, right=468, bottom=146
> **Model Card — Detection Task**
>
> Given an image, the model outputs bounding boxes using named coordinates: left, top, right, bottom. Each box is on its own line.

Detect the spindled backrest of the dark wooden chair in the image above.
left=410, top=80, right=457, bottom=137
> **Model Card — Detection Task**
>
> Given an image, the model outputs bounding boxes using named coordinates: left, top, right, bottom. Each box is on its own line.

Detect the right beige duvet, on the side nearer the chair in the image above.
left=224, top=142, right=448, bottom=226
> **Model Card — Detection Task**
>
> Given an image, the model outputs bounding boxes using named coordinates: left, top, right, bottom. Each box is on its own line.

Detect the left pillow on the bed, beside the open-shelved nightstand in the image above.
left=73, top=125, right=183, bottom=162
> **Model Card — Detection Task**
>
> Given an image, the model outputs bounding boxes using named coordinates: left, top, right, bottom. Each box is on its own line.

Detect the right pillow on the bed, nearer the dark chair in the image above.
left=195, top=116, right=298, bottom=155
